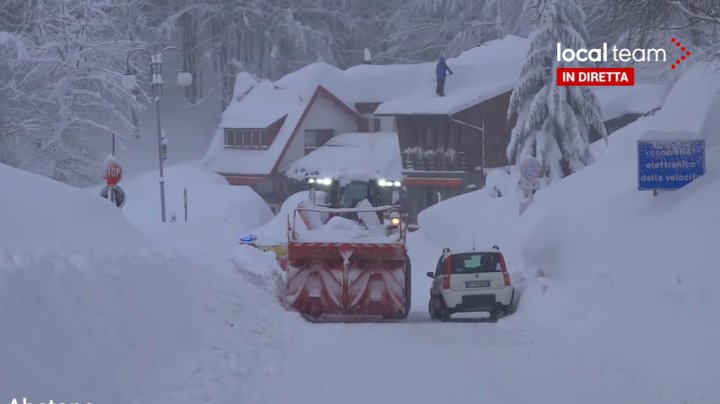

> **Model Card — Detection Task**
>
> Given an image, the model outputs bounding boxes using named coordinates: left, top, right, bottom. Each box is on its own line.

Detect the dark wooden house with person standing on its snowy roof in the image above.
left=375, top=36, right=528, bottom=222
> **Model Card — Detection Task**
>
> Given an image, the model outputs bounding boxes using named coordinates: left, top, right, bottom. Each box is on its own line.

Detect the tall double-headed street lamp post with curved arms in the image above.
left=122, top=46, right=192, bottom=223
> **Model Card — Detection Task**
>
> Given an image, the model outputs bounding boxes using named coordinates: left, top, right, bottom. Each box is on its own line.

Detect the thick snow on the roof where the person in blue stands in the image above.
left=376, top=35, right=529, bottom=115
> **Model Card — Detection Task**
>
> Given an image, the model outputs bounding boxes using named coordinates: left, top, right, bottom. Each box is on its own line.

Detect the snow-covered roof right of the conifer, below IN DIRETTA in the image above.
left=592, top=84, right=670, bottom=121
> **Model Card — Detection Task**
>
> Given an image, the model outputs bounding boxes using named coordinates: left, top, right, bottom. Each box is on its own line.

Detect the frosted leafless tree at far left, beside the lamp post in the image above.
left=11, top=0, right=142, bottom=184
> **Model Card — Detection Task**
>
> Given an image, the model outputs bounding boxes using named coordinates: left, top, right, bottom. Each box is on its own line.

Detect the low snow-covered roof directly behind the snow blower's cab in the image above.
left=285, top=132, right=402, bottom=181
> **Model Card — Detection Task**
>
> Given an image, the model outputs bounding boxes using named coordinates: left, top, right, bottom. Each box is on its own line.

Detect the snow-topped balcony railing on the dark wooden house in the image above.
left=402, top=146, right=470, bottom=172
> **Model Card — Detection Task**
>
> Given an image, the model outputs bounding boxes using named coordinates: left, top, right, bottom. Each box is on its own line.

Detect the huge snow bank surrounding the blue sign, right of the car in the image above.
left=410, top=65, right=720, bottom=403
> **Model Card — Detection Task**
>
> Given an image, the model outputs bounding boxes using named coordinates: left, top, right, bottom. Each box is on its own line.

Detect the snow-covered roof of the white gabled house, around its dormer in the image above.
left=206, top=59, right=425, bottom=174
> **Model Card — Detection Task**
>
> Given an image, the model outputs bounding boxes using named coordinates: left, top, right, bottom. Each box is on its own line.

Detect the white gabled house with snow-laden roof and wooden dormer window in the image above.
left=205, top=63, right=419, bottom=211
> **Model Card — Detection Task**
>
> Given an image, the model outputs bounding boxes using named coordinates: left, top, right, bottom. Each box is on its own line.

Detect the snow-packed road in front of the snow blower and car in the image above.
left=267, top=232, right=534, bottom=404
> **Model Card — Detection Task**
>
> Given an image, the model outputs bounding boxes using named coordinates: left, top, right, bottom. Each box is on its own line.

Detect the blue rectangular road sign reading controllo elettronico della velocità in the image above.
left=638, top=139, right=705, bottom=191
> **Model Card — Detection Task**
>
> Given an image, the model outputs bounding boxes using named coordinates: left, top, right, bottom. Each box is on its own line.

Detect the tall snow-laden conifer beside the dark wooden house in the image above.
left=507, top=0, right=607, bottom=182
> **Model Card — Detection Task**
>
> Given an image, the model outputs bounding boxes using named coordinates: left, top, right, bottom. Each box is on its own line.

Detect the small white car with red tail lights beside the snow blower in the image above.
left=427, top=246, right=515, bottom=321
